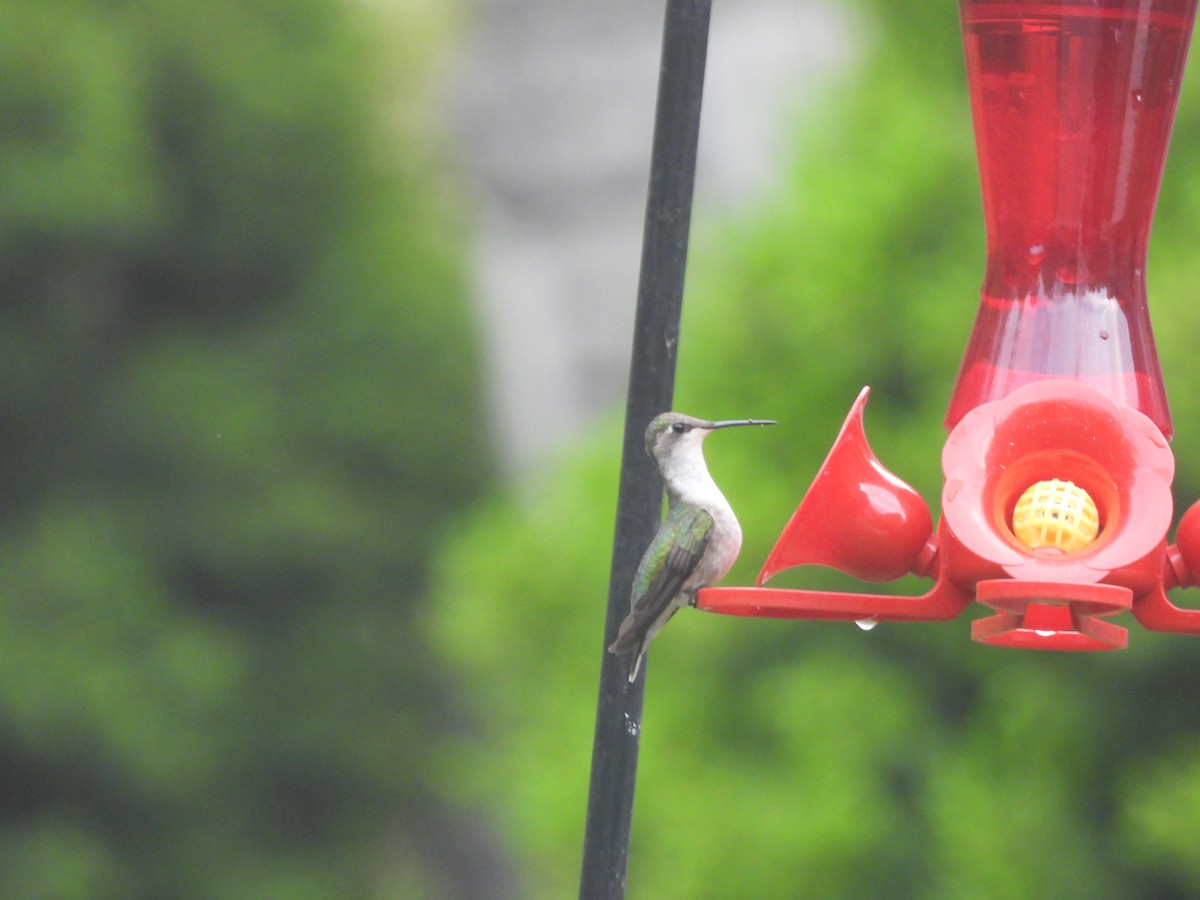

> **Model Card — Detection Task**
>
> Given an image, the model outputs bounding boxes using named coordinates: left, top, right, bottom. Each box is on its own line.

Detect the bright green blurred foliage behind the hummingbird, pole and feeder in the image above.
left=428, top=0, right=1200, bottom=900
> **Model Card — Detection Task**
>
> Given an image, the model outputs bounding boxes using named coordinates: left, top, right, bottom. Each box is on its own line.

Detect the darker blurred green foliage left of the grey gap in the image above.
left=0, top=0, right=490, bottom=900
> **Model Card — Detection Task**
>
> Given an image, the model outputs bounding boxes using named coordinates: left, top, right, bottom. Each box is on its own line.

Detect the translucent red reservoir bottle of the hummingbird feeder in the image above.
left=946, top=0, right=1198, bottom=438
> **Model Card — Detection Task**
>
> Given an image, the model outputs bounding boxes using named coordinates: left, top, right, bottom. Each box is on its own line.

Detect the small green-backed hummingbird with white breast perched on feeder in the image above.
left=608, top=413, right=775, bottom=683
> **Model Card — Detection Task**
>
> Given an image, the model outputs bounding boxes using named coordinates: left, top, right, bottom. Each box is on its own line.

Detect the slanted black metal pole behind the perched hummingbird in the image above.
left=580, top=0, right=712, bottom=900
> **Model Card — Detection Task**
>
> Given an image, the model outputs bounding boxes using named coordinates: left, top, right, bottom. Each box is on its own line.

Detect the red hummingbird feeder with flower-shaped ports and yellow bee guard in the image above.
left=697, top=0, right=1200, bottom=650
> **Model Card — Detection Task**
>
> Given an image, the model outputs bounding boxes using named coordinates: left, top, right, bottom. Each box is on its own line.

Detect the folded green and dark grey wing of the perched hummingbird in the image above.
left=608, top=505, right=713, bottom=653
